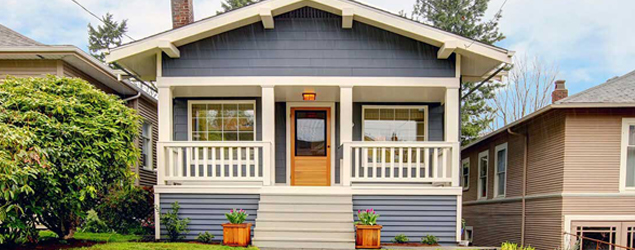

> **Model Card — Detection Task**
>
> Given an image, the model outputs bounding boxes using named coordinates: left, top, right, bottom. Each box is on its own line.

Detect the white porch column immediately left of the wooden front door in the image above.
left=262, top=85, right=276, bottom=186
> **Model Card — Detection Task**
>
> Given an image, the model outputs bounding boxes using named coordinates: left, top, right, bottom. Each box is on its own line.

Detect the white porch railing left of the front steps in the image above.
left=158, top=141, right=271, bottom=185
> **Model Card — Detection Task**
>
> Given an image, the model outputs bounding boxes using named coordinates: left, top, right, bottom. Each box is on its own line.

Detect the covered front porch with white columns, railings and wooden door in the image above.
left=157, top=77, right=460, bottom=190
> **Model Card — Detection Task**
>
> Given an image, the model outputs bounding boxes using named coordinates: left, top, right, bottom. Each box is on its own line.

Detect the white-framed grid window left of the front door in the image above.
left=188, top=101, right=256, bottom=141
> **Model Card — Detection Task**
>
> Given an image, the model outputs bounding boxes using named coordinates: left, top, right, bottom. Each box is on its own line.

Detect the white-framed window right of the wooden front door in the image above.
left=362, top=106, right=428, bottom=141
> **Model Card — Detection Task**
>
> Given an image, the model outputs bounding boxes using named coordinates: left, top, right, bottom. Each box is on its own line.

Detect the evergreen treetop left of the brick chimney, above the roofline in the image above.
left=88, top=13, right=128, bottom=62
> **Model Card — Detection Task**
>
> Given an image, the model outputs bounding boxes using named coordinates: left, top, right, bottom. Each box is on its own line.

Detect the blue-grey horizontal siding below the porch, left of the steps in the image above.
left=160, top=194, right=260, bottom=240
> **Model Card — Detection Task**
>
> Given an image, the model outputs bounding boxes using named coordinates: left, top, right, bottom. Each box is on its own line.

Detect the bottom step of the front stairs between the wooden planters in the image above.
left=253, top=237, right=355, bottom=250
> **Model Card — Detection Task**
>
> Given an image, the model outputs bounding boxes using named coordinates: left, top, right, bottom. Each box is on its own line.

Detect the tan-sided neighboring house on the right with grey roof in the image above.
left=461, top=76, right=635, bottom=250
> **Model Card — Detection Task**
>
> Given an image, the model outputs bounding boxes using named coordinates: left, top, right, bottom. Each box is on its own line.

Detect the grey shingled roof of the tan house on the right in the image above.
left=556, top=70, right=635, bottom=104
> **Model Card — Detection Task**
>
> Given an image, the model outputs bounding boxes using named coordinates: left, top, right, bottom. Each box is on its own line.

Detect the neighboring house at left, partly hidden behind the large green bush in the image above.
left=0, top=25, right=158, bottom=186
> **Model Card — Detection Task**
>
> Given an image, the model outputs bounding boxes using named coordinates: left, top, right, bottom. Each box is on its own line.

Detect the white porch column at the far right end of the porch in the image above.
left=444, top=88, right=461, bottom=187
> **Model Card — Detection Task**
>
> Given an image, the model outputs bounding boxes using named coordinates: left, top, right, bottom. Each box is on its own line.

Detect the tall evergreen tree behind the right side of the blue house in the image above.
left=412, top=0, right=505, bottom=145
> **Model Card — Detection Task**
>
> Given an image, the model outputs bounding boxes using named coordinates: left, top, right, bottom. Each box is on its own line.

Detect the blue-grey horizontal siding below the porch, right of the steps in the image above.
left=353, top=195, right=457, bottom=244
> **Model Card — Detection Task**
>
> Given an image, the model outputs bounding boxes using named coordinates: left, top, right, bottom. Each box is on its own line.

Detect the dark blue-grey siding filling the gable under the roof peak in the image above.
left=163, top=7, right=455, bottom=77
